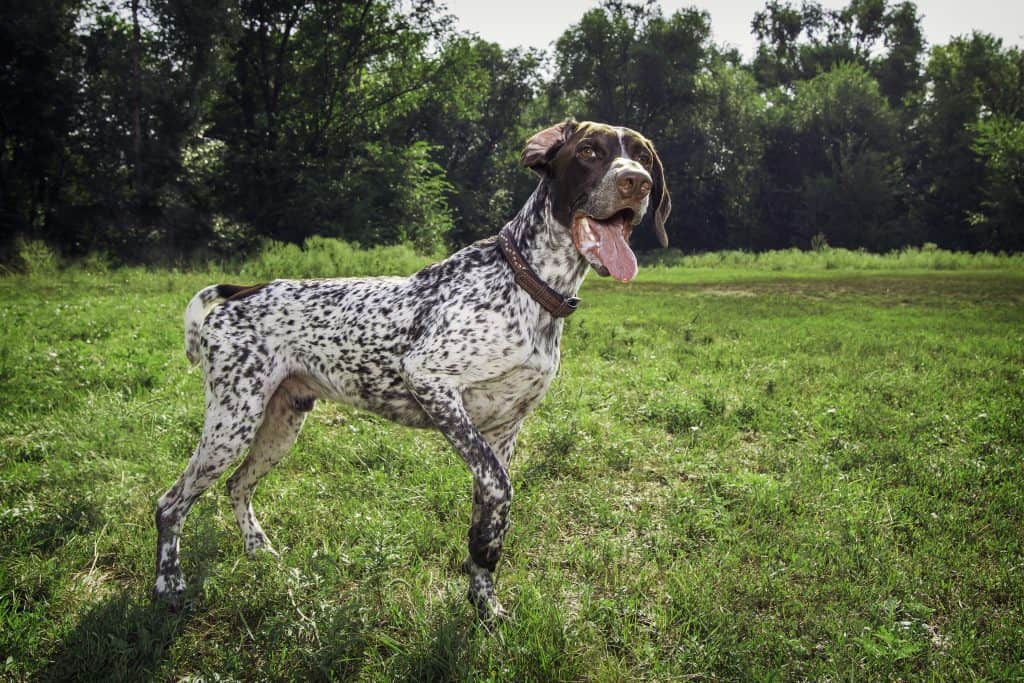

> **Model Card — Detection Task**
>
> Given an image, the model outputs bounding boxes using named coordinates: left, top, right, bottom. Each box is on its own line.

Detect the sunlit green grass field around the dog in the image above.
left=0, top=248, right=1024, bottom=681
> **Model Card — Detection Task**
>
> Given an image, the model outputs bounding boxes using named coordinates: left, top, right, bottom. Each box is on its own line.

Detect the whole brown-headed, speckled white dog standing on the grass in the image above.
left=148, top=120, right=671, bottom=622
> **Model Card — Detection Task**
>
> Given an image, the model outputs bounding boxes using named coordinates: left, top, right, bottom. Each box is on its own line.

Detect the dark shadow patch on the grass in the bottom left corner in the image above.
left=40, top=591, right=190, bottom=681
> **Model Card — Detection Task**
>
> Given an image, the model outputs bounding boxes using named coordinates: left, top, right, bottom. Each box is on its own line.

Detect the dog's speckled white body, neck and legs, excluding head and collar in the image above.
left=156, top=161, right=606, bottom=610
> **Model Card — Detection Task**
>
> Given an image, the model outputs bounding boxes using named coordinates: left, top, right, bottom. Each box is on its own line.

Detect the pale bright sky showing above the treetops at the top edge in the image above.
left=445, top=0, right=1024, bottom=57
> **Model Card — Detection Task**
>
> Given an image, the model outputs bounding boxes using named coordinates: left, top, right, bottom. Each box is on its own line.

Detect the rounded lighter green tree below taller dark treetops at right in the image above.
left=761, top=65, right=907, bottom=249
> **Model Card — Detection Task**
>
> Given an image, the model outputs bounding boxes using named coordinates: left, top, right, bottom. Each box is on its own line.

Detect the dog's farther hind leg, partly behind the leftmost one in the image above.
left=227, top=380, right=313, bottom=557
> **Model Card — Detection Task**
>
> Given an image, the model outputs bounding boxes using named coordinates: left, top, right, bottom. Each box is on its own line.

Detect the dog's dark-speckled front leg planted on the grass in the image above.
left=403, top=364, right=512, bottom=622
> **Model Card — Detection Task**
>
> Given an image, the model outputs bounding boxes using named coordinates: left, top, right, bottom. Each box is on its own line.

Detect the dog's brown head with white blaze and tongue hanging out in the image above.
left=522, top=119, right=672, bottom=282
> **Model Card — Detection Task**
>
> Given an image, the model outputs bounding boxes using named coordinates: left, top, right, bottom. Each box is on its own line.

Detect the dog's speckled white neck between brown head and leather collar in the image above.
left=506, top=178, right=590, bottom=296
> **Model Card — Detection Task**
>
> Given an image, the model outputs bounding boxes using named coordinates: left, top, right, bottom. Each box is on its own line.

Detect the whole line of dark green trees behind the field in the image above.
left=0, top=0, right=1024, bottom=261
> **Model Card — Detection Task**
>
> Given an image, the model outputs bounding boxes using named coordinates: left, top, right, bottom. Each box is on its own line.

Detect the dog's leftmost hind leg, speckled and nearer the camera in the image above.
left=154, top=368, right=267, bottom=608
